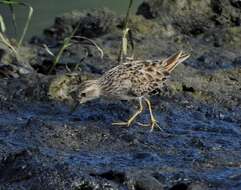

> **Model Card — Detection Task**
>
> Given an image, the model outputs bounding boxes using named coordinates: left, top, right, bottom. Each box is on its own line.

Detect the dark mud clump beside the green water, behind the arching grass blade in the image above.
left=44, top=9, right=115, bottom=40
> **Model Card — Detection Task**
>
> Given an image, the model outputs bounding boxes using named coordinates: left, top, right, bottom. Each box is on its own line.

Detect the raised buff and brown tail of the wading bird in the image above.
left=162, top=51, right=190, bottom=73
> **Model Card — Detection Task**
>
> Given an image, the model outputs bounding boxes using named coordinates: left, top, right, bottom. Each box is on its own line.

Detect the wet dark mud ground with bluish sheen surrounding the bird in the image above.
left=0, top=0, right=241, bottom=190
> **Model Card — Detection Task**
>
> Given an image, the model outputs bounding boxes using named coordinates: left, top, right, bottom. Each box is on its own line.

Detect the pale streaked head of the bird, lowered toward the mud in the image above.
left=76, top=80, right=100, bottom=104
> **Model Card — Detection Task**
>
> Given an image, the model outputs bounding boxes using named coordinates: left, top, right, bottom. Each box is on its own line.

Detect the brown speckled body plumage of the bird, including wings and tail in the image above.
left=98, top=52, right=189, bottom=99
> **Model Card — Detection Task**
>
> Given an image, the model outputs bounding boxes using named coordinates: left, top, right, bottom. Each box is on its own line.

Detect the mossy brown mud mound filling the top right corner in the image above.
left=137, top=0, right=241, bottom=36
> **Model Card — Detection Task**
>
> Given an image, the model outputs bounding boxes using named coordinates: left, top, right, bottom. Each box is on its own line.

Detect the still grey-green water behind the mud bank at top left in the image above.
left=0, top=0, right=142, bottom=39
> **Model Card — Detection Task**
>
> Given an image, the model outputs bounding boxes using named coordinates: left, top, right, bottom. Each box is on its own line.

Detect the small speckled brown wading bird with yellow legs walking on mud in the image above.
left=74, top=51, right=189, bottom=131
